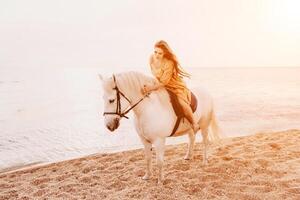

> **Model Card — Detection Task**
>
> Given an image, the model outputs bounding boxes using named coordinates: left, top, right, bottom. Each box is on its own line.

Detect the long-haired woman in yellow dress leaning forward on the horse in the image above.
left=143, top=40, right=199, bottom=132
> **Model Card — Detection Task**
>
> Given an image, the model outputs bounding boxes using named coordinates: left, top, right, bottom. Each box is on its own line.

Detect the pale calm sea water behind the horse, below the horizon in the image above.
left=0, top=68, right=300, bottom=169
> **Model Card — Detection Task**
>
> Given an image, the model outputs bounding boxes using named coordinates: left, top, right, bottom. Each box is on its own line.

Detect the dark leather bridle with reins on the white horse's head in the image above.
left=103, top=75, right=149, bottom=119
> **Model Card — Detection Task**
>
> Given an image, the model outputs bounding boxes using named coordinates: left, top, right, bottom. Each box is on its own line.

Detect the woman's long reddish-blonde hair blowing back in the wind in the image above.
left=154, top=40, right=191, bottom=78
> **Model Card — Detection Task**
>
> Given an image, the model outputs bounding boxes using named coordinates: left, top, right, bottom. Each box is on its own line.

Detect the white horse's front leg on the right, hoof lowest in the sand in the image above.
left=154, top=138, right=165, bottom=184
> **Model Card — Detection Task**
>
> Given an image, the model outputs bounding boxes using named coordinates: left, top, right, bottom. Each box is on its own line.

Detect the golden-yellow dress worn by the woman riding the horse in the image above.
left=150, top=59, right=191, bottom=104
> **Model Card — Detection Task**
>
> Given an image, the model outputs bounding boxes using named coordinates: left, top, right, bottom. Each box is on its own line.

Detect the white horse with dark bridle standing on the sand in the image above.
left=99, top=72, right=219, bottom=183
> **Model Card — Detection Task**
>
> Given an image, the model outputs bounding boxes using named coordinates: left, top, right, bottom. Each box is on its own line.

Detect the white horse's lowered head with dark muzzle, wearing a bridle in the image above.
left=99, top=75, right=130, bottom=131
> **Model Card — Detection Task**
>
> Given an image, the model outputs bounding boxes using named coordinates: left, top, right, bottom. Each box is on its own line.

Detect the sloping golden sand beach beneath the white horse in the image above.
left=0, top=130, right=300, bottom=200
